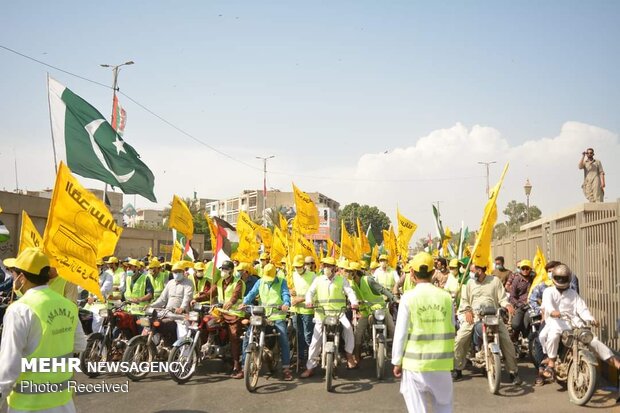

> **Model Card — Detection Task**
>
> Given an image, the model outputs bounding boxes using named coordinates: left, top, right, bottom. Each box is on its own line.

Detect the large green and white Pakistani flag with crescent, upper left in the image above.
left=48, top=77, right=157, bottom=202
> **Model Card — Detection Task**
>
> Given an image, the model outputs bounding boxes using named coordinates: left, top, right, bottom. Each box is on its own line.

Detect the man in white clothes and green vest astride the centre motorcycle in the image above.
left=299, top=257, right=359, bottom=378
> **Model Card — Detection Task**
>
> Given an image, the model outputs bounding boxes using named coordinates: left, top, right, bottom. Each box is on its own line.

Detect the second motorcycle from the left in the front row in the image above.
left=122, top=308, right=185, bottom=381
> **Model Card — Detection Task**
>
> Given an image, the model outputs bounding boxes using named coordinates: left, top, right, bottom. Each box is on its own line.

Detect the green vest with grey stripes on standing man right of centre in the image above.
left=403, top=283, right=455, bottom=372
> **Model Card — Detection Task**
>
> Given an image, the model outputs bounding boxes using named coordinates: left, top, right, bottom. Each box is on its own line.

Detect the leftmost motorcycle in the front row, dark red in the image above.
left=80, top=303, right=138, bottom=378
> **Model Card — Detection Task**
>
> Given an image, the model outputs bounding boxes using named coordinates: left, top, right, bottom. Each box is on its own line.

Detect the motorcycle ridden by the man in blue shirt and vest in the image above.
left=243, top=306, right=280, bottom=392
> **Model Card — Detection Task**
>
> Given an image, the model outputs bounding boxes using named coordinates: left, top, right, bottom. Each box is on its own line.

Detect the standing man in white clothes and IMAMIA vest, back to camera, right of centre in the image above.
left=392, top=252, right=455, bottom=413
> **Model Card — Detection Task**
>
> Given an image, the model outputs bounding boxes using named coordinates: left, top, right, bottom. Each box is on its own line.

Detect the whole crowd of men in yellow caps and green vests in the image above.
left=0, top=248, right=620, bottom=411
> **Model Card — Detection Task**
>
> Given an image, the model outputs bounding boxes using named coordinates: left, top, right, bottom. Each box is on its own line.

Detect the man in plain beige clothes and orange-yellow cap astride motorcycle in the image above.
left=452, top=257, right=522, bottom=385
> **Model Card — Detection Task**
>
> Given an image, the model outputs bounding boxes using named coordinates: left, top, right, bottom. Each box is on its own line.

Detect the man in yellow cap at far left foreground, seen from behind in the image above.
left=0, top=248, right=86, bottom=412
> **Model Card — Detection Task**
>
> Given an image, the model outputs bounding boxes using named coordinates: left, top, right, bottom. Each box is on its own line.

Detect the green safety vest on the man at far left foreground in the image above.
left=8, top=288, right=78, bottom=410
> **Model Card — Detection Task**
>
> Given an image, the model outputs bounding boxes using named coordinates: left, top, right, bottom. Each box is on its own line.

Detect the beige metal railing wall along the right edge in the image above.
left=493, top=201, right=620, bottom=350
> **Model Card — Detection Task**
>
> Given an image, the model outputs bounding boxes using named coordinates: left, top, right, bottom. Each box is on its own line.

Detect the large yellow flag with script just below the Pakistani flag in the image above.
left=43, top=162, right=123, bottom=301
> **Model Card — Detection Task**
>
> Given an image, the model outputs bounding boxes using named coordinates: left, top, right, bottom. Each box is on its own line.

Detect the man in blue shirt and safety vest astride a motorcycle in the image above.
left=241, top=264, right=293, bottom=381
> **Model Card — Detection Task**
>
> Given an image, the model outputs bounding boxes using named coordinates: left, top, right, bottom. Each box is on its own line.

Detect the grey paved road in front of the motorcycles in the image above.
left=48, top=359, right=620, bottom=413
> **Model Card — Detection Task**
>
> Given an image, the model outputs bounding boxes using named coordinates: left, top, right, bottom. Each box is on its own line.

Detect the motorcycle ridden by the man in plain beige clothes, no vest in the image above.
left=470, top=307, right=502, bottom=394
